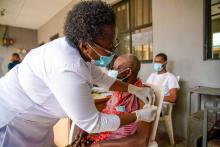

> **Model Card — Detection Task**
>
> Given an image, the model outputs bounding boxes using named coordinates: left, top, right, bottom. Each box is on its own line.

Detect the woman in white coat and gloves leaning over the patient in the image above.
left=0, top=1, right=156, bottom=147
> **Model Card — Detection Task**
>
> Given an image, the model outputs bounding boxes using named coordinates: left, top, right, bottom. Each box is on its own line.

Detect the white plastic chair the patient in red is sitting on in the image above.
left=68, top=84, right=164, bottom=147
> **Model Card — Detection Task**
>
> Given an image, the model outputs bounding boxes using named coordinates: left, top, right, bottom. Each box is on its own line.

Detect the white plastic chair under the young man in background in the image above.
left=160, top=76, right=180, bottom=145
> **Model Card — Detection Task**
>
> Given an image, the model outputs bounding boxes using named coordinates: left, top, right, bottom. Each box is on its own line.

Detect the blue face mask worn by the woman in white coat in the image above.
left=88, top=44, right=115, bottom=67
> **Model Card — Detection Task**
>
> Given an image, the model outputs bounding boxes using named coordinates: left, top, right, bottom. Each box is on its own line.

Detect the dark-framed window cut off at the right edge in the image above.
left=204, top=0, right=220, bottom=60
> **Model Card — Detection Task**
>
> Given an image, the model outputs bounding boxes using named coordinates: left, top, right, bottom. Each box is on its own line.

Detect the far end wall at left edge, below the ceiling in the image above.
left=0, top=26, right=37, bottom=77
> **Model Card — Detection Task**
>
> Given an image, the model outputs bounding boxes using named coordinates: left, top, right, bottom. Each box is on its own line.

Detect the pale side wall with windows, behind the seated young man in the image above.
left=38, top=0, right=220, bottom=137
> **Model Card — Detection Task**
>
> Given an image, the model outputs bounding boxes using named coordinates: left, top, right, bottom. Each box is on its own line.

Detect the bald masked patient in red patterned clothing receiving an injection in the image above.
left=71, top=55, right=152, bottom=147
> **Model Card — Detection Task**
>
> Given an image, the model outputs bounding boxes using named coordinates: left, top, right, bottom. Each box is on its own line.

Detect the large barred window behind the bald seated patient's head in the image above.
left=113, top=0, right=153, bottom=62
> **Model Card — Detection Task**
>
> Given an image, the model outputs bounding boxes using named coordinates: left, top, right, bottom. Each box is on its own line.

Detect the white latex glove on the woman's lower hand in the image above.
left=134, top=105, right=157, bottom=122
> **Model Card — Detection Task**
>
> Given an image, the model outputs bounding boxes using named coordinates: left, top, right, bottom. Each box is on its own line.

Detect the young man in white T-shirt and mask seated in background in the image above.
left=146, top=53, right=179, bottom=113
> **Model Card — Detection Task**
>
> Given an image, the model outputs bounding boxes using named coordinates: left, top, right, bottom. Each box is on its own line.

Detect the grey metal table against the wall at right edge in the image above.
left=187, top=86, right=220, bottom=146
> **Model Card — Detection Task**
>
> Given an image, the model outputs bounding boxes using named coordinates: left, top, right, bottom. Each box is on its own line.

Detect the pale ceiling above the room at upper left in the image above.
left=0, top=0, right=118, bottom=29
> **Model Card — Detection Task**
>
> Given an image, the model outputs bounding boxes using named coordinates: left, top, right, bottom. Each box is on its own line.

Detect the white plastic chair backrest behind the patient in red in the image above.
left=149, top=84, right=164, bottom=142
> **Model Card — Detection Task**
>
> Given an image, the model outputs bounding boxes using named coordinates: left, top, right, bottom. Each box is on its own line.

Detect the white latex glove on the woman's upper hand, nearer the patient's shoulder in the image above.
left=128, top=84, right=155, bottom=106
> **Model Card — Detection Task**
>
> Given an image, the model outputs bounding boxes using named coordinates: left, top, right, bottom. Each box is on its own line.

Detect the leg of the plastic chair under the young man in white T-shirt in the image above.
left=164, top=115, right=175, bottom=145
